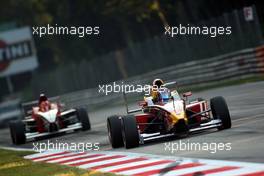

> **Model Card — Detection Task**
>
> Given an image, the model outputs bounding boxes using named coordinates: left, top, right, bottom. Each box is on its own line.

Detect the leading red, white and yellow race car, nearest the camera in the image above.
left=107, top=82, right=231, bottom=148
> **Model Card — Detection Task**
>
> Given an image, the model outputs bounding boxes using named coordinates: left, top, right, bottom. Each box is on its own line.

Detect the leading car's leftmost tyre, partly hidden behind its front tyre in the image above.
left=107, top=115, right=124, bottom=148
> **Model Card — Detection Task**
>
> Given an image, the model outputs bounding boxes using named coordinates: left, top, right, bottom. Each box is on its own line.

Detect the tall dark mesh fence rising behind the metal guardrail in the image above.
left=29, top=6, right=263, bottom=97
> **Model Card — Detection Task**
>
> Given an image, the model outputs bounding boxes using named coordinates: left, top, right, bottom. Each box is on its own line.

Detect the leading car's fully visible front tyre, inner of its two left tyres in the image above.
left=121, top=115, right=139, bottom=149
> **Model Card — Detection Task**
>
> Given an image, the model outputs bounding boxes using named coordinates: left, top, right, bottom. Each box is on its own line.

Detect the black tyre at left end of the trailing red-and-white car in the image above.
left=9, top=121, right=26, bottom=145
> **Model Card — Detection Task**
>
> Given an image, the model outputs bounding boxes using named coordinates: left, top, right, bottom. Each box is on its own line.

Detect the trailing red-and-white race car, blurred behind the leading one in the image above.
left=9, top=95, right=91, bottom=145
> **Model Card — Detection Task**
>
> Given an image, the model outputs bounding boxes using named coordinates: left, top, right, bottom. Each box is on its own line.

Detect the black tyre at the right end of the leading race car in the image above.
left=210, top=96, right=231, bottom=130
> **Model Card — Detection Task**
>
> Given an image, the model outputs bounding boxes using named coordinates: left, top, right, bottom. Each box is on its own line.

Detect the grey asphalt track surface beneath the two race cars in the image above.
left=0, top=82, right=264, bottom=163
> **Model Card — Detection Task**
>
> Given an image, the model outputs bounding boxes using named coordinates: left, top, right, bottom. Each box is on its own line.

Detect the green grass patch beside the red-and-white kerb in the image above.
left=0, top=149, right=114, bottom=176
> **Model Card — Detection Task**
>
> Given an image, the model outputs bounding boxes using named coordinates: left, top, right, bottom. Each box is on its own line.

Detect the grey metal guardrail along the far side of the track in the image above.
left=61, top=46, right=264, bottom=107
